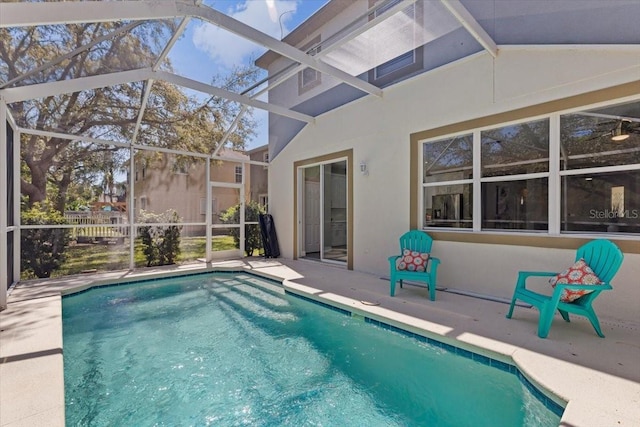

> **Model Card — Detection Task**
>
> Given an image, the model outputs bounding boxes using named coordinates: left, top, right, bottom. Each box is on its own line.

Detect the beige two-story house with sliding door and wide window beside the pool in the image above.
left=256, top=0, right=640, bottom=321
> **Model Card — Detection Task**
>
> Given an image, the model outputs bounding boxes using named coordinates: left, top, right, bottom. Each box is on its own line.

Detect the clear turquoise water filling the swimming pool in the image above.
left=63, top=273, right=560, bottom=427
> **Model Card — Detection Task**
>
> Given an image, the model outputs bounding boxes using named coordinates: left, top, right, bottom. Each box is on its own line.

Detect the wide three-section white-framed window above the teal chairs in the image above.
left=422, top=101, right=640, bottom=234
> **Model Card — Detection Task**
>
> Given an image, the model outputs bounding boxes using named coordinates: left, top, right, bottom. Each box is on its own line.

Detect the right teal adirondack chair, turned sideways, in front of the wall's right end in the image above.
left=507, top=239, right=624, bottom=338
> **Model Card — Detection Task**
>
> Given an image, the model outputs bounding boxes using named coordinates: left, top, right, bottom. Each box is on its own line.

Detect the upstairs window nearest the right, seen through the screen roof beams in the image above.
left=369, top=0, right=424, bottom=86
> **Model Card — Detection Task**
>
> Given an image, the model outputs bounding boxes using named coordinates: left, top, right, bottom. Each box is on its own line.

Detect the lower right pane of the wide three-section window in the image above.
left=561, top=170, right=640, bottom=233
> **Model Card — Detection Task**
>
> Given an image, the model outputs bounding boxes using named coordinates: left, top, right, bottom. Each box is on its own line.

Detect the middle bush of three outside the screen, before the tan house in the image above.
left=139, top=210, right=182, bottom=267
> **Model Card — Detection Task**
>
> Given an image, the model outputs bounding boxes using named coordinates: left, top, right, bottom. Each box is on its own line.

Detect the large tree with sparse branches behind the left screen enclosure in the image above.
left=0, top=20, right=258, bottom=212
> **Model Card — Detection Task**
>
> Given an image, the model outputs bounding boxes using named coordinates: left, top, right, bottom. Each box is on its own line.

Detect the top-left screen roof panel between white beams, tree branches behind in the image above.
left=0, top=20, right=177, bottom=87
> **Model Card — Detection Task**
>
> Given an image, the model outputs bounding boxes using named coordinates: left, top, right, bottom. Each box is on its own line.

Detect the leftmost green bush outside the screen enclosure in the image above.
left=20, top=203, right=71, bottom=278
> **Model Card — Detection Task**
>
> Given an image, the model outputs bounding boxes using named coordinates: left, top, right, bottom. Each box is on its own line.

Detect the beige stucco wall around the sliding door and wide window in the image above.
left=269, top=46, right=640, bottom=324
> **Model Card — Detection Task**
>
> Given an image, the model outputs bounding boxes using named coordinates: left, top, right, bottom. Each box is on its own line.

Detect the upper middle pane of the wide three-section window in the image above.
left=481, top=119, right=549, bottom=177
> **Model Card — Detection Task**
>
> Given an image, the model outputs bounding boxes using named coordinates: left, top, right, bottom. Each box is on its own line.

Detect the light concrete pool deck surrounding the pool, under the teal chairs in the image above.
left=0, top=258, right=640, bottom=427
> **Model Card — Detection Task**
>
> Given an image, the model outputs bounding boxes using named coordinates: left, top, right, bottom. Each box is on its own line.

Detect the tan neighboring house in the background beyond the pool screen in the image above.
left=134, top=150, right=251, bottom=235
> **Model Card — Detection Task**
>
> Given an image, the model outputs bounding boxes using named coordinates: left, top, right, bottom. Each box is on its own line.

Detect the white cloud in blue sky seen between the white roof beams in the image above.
left=193, top=0, right=298, bottom=68
